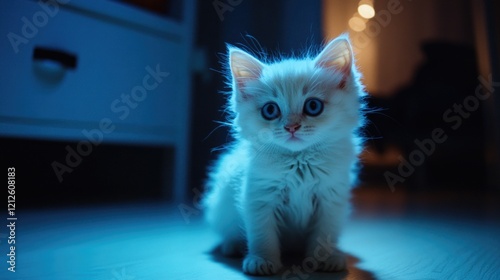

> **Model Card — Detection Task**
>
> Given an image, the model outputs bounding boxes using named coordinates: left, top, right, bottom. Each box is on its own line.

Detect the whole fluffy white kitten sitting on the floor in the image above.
left=204, top=35, right=365, bottom=275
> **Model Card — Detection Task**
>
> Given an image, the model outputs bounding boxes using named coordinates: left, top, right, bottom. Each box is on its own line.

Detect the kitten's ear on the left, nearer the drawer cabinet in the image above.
left=229, top=48, right=264, bottom=98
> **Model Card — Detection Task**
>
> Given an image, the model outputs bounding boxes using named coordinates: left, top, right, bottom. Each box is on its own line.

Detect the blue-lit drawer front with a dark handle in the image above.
left=0, top=0, right=185, bottom=137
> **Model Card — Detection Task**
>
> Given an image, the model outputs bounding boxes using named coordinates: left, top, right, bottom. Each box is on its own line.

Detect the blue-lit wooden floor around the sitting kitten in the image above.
left=0, top=189, right=500, bottom=280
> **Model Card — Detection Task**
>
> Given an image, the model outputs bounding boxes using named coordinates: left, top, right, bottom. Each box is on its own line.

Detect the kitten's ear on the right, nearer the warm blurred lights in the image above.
left=315, top=35, right=353, bottom=88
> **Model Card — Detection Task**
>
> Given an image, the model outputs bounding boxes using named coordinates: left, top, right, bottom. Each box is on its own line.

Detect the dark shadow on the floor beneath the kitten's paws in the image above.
left=208, top=246, right=376, bottom=280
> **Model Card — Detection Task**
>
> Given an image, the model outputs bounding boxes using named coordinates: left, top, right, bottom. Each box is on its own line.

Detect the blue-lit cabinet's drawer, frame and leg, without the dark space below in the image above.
left=0, top=0, right=194, bottom=202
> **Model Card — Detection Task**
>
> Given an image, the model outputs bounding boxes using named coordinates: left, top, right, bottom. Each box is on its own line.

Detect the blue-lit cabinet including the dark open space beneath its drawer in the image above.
left=0, top=0, right=195, bottom=207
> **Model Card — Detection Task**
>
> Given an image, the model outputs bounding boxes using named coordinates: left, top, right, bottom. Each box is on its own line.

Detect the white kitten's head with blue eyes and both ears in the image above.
left=229, top=36, right=364, bottom=151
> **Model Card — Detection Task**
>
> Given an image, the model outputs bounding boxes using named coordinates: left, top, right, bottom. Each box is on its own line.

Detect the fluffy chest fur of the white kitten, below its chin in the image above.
left=250, top=147, right=336, bottom=230
